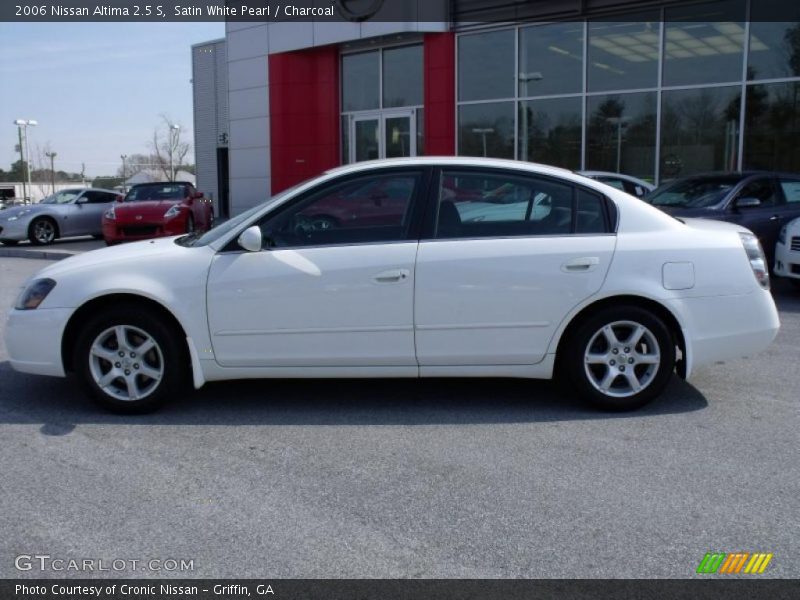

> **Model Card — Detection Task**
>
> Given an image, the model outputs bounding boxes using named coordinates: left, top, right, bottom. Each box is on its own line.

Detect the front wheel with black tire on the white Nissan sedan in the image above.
left=74, top=304, right=189, bottom=414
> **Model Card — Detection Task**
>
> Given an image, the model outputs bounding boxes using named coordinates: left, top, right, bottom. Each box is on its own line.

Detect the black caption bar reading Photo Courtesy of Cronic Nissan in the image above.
left=0, top=577, right=800, bottom=600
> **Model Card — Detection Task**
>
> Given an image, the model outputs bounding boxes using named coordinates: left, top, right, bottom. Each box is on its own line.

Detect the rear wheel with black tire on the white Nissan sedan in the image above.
left=559, top=306, right=675, bottom=411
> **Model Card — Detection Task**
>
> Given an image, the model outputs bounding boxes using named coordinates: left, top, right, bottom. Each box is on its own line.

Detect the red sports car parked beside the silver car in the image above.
left=103, top=181, right=214, bottom=246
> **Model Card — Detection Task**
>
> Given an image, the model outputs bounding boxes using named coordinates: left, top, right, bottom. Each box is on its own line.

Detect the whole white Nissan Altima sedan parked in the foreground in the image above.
left=6, top=158, right=779, bottom=412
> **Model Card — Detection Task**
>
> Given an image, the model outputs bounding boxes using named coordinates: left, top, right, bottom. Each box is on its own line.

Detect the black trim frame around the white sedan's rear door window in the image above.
left=419, top=164, right=619, bottom=242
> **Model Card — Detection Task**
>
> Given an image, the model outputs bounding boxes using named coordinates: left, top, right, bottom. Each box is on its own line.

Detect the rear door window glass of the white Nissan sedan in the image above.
left=435, top=171, right=606, bottom=239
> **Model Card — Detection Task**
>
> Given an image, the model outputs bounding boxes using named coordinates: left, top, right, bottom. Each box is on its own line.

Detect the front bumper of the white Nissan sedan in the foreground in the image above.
left=5, top=308, right=72, bottom=377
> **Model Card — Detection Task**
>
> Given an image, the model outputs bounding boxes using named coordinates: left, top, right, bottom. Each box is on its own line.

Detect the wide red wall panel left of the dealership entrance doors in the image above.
left=269, top=46, right=340, bottom=194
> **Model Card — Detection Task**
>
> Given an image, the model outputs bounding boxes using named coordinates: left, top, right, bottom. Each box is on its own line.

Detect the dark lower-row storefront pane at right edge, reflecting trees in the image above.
left=743, top=82, right=800, bottom=172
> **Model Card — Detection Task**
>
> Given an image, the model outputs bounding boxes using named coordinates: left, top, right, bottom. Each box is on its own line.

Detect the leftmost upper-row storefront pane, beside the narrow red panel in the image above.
left=458, top=29, right=516, bottom=100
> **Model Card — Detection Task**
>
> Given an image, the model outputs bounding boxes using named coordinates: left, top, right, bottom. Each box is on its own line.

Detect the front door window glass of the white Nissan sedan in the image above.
left=260, top=173, right=419, bottom=248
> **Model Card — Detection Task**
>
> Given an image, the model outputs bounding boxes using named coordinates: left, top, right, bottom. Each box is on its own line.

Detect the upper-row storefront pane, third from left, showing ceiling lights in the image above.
left=586, top=12, right=661, bottom=92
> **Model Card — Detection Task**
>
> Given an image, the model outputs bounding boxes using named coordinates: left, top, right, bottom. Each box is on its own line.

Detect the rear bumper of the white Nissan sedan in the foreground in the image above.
left=678, top=289, right=780, bottom=377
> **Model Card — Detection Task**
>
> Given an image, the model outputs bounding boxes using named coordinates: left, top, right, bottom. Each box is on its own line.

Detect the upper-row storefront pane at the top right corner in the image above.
left=747, top=0, right=800, bottom=80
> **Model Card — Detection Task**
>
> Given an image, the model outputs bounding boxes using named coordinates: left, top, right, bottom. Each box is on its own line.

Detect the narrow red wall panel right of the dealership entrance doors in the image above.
left=424, top=32, right=456, bottom=156
